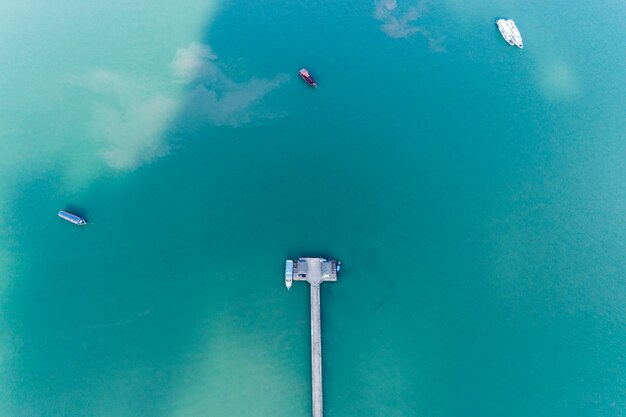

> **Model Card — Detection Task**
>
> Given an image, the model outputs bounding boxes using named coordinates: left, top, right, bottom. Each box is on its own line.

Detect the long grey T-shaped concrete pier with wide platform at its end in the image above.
left=285, top=258, right=339, bottom=417
